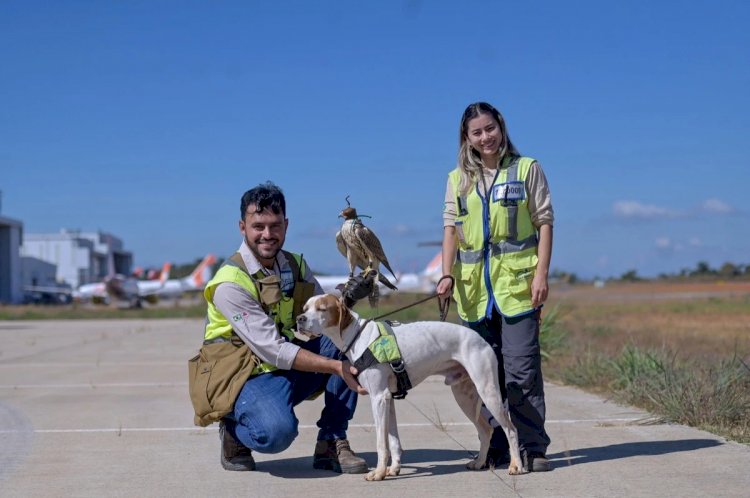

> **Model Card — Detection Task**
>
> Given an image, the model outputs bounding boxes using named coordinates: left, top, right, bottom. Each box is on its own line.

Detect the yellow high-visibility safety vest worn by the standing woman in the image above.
left=448, top=156, right=538, bottom=323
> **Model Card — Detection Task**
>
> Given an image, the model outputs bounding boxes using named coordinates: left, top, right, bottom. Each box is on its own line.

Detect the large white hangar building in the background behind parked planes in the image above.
left=21, top=229, right=133, bottom=288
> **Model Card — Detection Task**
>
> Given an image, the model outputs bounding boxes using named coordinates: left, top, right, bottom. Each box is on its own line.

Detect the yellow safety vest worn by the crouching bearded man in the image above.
left=203, top=251, right=312, bottom=375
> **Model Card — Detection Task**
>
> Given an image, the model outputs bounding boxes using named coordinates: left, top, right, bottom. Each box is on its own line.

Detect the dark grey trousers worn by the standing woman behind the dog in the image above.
left=466, top=310, right=550, bottom=453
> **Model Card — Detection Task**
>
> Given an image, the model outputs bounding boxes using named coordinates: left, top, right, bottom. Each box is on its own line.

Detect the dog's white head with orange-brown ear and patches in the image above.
left=297, top=294, right=354, bottom=342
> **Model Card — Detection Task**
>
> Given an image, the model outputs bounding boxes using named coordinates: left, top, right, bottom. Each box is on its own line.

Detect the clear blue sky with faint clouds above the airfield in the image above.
left=0, top=0, right=750, bottom=278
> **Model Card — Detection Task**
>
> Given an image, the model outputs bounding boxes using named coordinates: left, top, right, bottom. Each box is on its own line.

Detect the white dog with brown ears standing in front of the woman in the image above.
left=297, top=294, right=523, bottom=481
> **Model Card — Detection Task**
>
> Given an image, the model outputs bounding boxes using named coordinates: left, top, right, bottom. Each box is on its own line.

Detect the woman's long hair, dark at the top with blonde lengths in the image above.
left=458, top=102, right=520, bottom=194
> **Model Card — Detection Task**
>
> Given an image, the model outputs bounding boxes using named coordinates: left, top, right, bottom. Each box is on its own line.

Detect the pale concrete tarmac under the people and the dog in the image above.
left=0, top=319, right=750, bottom=498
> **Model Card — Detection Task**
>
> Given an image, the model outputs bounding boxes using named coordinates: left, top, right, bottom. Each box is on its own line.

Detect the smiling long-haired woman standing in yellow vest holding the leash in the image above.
left=437, top=102, right=554, bottom=472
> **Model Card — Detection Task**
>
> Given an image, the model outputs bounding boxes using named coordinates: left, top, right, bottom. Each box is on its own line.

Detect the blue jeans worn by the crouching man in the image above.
left=223, top=336, right=357, bottom=453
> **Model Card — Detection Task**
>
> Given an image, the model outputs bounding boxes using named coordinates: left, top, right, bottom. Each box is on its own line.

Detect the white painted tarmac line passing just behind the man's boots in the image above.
left=0, top=417, right=643, bottom=434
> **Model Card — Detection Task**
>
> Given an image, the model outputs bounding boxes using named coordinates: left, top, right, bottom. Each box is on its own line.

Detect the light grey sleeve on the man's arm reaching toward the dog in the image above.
left=214, top=282, right=300, bottom=370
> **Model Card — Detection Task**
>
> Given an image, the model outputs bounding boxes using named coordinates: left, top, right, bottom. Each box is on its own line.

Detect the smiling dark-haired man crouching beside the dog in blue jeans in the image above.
left=203, top=182, right=372, bottom=474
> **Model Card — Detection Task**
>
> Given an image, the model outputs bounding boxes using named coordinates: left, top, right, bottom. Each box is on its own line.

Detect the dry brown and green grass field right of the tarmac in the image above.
left=546, top=283, right=750, bottom=443
